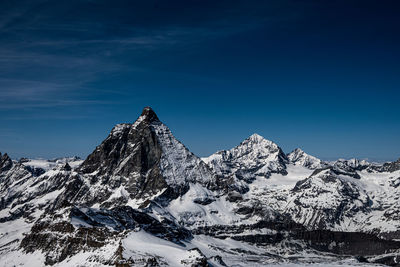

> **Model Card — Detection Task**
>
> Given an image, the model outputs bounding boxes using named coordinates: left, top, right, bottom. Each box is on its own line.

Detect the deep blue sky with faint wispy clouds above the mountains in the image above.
left=0, top=0, right=400, bottom=161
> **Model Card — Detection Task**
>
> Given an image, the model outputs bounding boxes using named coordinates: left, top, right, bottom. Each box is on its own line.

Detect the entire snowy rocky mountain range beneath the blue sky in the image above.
left=0, top=107, right=400, bottom=267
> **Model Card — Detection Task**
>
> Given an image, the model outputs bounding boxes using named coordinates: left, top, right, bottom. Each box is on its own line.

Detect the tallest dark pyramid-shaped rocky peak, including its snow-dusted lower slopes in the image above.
left=54, top=107, right=216, bottom=207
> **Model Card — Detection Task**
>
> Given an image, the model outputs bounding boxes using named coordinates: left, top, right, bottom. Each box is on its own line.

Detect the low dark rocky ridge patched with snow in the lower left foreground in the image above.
left=21, top=206, right=192, bottom=265
